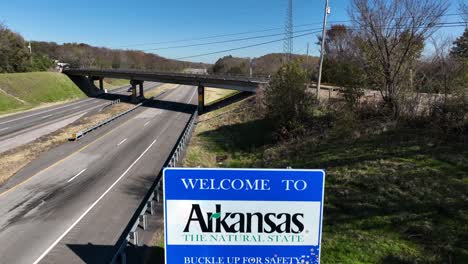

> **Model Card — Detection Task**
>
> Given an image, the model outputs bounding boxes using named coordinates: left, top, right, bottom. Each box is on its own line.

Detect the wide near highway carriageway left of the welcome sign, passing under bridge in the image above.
left=0, top=86, right=197, bottom=263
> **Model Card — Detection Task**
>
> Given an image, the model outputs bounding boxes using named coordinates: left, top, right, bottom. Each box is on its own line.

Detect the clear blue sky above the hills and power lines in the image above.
left=0, top=0, right=462, bottom=62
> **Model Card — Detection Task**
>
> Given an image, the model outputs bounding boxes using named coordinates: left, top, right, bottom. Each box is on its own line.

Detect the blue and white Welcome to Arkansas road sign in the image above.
left=163, top=168, right=325, bottom=264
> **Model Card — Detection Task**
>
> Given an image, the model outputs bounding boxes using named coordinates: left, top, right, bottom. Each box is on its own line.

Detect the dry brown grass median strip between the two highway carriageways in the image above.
left=0, top=103, right=133, bottom=185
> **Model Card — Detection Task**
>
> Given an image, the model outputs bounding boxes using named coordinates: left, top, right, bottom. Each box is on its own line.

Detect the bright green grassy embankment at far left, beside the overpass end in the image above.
left=0, top=72, right=86, bottom=115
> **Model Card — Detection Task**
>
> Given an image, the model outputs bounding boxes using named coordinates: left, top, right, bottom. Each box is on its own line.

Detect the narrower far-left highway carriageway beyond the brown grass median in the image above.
left=0, top=82, right=161, bottom=153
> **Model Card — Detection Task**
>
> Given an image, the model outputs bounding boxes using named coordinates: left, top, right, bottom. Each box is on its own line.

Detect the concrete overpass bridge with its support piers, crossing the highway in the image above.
left=63, top=69, right=268, bottom=113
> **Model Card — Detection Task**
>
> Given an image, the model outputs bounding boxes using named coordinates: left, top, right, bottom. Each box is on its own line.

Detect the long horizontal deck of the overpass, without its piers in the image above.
left=63, top=69, right=268, bottom=92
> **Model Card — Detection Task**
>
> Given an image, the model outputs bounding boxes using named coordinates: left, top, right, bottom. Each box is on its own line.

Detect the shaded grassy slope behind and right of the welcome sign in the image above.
left=178, top=99, right=468, bottom=263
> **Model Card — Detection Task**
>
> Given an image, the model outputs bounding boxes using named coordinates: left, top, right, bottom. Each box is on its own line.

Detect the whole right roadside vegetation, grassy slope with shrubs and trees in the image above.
left=184, top=0, right=468, bottom=263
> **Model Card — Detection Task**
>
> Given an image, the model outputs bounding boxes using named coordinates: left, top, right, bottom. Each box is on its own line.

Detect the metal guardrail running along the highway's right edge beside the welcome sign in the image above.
left=110, top=112, right=198, bottom=264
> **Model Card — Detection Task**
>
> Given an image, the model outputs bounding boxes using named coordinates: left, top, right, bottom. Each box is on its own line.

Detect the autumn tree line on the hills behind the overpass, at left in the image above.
left=0, top=24, right=208, bottom=73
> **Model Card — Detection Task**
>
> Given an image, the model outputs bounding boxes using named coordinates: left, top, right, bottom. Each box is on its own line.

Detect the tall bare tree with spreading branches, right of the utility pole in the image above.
left=350, top=0, right=448, bottom=117
